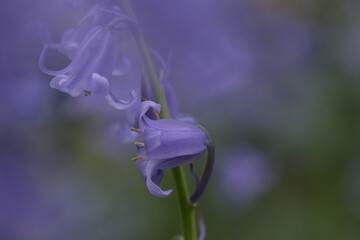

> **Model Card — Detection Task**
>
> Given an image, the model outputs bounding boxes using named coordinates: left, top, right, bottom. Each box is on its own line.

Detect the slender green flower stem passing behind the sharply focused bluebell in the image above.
left=120, top=0, right=197, bottom=240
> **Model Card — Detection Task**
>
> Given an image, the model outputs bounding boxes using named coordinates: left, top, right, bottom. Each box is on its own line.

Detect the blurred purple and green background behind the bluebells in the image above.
left=0, top=0, right=360, bottom=240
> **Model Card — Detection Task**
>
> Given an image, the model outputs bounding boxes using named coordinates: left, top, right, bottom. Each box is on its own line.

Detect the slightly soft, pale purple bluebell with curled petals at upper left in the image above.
left=39, top=4, right=136, bottom=109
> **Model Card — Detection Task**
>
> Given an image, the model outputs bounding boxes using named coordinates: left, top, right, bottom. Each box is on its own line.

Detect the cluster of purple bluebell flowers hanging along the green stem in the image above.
left=39, top=1, right=212, bottom=201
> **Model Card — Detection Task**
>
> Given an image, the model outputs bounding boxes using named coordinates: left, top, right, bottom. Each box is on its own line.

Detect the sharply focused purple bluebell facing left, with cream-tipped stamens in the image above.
left=134, top=101, right=207, bottom=197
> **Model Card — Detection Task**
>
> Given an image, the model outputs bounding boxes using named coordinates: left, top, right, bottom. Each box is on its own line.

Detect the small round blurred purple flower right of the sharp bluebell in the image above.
left=219, top=149, right=275, bottom=206
